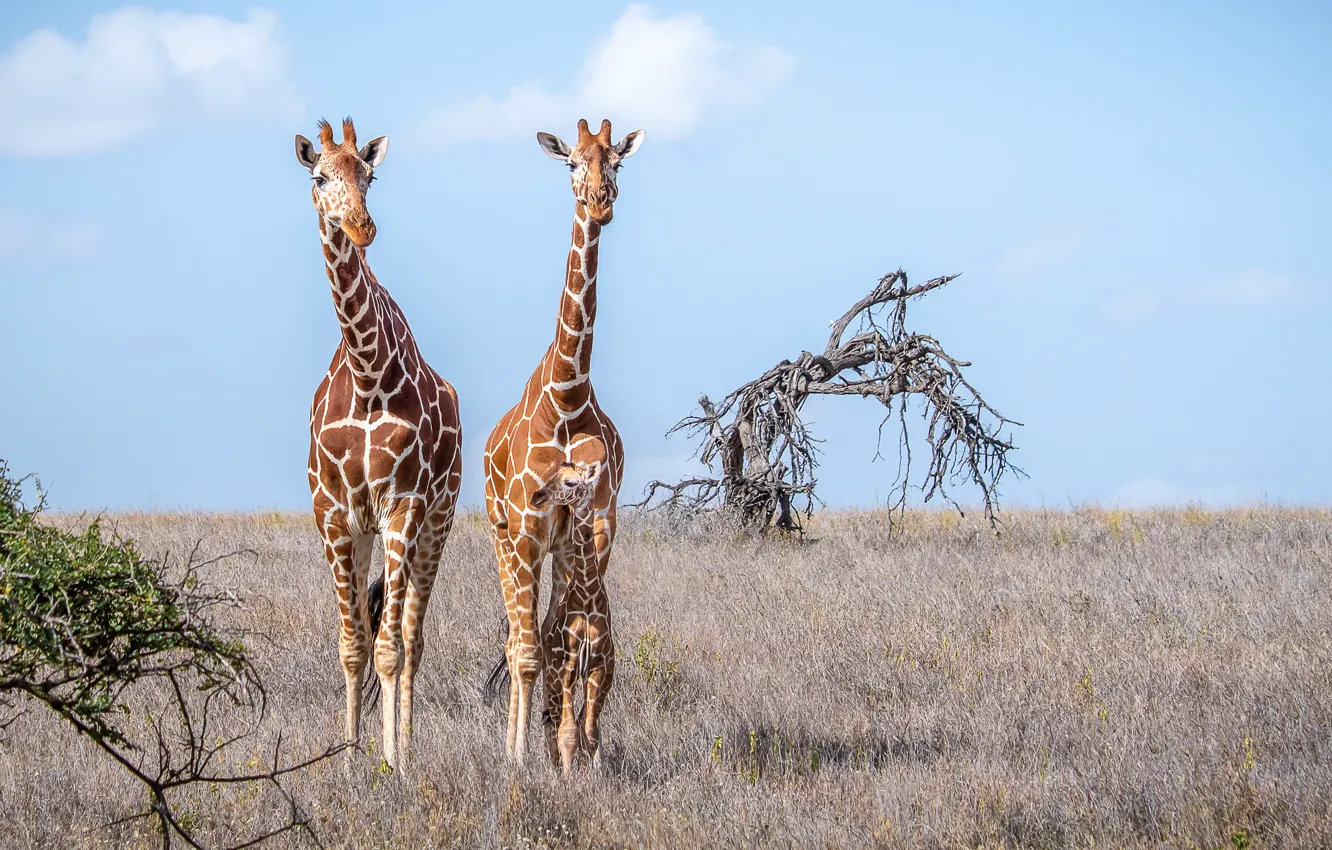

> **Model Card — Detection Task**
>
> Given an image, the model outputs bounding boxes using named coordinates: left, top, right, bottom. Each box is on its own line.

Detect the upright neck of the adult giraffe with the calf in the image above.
left=550, top=204, right=601, bottom=410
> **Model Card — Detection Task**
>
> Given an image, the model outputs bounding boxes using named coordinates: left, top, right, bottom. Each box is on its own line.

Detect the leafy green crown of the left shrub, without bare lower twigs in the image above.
left=0, top=461, right=253, bottom=743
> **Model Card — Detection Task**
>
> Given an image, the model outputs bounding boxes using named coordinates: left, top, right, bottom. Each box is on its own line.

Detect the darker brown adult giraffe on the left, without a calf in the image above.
left=296, top=119, right=462, bottom=767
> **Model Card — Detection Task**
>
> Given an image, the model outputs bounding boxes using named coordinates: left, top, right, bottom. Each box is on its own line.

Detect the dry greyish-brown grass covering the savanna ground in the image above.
left=0, top=508, right=1332, bottom=849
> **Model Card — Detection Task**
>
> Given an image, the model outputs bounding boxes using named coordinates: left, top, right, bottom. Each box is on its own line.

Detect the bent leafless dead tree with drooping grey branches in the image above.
left=638, top=269, right=1023, bottom=530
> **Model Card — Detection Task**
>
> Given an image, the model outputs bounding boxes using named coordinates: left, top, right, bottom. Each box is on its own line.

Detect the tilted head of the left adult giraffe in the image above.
left=296, top=119, right=389, bottom=248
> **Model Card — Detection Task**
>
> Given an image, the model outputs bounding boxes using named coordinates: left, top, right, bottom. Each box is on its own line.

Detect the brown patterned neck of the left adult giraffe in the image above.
left=320, top=213, right=393, bottom=381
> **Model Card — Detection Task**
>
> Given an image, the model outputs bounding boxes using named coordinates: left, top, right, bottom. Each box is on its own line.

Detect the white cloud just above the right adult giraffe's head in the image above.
left=416, top=5, right=794, bottom=145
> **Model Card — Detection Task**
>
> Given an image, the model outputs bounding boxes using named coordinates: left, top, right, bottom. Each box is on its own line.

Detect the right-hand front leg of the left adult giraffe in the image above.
left=374, top=500, right=425, bottom=769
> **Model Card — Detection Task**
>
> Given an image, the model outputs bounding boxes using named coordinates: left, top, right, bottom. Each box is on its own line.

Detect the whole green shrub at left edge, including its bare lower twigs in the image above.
left=0, top=460, right=344, bottom=846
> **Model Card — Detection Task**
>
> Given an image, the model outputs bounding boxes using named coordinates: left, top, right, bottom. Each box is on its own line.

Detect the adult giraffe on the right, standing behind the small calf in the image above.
left=484, top=120, right=643, bottom=762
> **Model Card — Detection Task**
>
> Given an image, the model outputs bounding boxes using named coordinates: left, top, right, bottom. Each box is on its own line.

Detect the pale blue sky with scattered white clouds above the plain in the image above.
left=0, top=0, right=1332, bottom=509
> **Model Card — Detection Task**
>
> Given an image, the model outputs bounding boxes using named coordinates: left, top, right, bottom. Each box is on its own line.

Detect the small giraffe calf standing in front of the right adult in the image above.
left=531, top=450, right=615, bottom=774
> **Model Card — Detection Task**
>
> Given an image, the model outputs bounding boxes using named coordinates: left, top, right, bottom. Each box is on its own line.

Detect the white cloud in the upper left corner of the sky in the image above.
left=0, top=7, right=300, bottom=156
